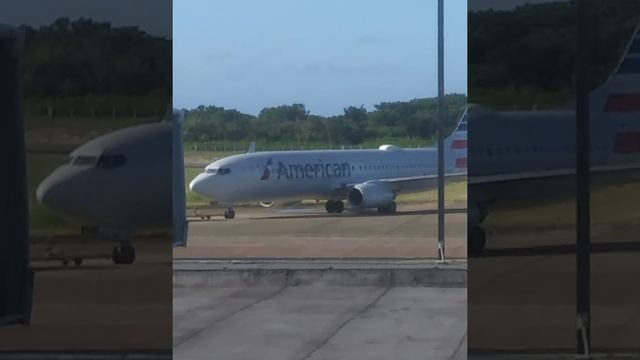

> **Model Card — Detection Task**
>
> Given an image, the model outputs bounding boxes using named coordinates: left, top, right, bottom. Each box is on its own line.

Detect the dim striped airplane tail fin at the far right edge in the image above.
left=591, top=23, right=640, bottom=115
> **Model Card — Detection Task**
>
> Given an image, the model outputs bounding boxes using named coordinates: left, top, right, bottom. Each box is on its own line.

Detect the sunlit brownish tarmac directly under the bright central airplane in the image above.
left=174, top=204, right=467, bottom=259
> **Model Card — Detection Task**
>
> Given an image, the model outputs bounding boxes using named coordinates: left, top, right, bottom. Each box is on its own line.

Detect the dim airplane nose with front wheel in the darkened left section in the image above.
left=36, top=108, right=184, bottom=264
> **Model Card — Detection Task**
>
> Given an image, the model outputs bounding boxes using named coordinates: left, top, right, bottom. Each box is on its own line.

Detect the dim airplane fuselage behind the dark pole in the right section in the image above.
left=469, top=111, right=640, bottom=178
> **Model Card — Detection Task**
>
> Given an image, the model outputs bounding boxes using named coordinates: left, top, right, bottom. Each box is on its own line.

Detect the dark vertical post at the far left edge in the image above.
left=0, top=27, right=33, bottom=325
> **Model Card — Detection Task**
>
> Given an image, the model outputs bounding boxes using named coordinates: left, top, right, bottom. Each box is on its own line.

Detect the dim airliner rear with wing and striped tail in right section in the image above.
left=468, top=21, right=640, bottom=252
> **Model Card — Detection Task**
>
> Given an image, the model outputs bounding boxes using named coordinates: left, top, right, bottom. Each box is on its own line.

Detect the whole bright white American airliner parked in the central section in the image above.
left=189, top=113, right=467, bottom=219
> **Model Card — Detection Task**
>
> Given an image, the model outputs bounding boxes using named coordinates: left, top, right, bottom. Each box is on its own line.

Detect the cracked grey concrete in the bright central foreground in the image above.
left=174, top=285, right=467, bottom=360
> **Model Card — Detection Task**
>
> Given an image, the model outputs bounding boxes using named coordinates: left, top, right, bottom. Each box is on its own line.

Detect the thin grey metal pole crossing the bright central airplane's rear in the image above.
left=438, top=0, right=446, bottom=261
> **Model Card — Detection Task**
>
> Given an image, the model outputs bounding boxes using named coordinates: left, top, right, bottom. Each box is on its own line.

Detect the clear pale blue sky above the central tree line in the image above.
left=173, top=0, right=467, bottom=115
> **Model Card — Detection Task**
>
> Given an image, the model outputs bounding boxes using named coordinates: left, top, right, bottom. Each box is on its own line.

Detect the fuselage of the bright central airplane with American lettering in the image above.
left=190, top=148, right=464, bottom=204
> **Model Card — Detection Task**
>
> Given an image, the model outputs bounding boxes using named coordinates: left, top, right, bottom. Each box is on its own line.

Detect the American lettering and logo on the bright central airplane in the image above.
left=260, top=159, right=351, bottom=180
